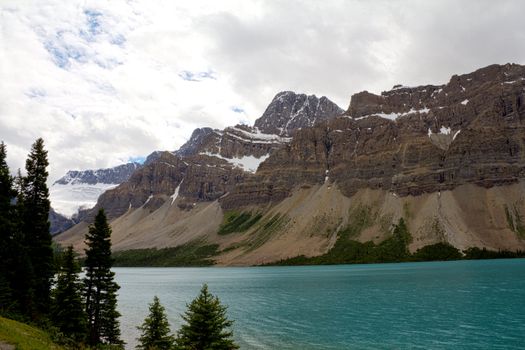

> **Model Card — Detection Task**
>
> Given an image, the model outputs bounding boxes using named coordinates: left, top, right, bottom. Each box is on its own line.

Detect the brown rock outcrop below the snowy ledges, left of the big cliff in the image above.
left=92, top=152, right=250, bottom=221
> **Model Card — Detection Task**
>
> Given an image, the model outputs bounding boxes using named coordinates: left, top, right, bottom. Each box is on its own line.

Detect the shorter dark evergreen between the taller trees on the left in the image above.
left=51, top=246, right=87, bottom=342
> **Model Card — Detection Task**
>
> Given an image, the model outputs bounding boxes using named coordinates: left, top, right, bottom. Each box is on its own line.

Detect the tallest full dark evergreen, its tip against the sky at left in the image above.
left=19, top=138, right=54, bottom=317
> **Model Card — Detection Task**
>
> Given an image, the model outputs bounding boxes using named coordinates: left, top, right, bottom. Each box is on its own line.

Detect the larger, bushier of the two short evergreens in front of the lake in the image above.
left=176, top=284, right=239, bottom=350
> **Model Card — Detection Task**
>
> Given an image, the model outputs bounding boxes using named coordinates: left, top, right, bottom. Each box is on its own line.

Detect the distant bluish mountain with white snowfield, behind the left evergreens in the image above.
left=49, top=163, right=141, bottom=219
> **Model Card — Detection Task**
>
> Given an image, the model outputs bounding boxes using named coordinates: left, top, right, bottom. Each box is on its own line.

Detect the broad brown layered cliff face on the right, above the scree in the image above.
left=221, top=64, right=525, bottom=208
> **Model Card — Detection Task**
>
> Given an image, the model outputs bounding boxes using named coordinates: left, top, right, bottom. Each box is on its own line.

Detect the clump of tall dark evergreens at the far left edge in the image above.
left=0, top=139, right=54, bottom=321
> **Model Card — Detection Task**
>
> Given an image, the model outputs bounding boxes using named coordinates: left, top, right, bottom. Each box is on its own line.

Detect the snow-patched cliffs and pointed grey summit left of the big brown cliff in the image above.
left=88, top=92, right=342, bottom=219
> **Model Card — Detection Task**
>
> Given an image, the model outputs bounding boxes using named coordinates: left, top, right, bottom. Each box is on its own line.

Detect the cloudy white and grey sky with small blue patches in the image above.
left=0, top=0, right=525, bottom=181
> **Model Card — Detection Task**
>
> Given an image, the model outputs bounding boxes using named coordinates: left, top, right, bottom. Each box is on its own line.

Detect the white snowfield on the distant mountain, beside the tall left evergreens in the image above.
left=49, top=183, right=118, bottom=218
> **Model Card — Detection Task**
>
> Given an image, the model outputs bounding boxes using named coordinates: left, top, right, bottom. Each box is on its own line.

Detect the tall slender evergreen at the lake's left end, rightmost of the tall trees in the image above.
left=84, top=209, right=123, bottom=345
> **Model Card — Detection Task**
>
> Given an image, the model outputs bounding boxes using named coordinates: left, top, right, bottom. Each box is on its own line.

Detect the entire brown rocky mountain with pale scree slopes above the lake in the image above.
left=53, top=64, right=525, bottom=265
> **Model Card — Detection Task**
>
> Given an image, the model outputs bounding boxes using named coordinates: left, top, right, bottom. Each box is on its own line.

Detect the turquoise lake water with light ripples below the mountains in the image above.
left=114, top=259, right=525, bottom=349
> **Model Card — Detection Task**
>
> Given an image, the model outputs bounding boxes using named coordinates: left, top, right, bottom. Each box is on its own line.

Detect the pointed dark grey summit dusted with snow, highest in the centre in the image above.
left=254, top=91, right=344, bottom=136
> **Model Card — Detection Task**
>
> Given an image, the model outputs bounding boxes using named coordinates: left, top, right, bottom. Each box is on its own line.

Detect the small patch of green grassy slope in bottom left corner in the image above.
left=0, top=317, right=64, bottom=350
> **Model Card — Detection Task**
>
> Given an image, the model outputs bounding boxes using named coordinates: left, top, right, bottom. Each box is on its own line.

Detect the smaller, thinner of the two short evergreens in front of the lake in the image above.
left=137, top=296, right=175, bottom=350
